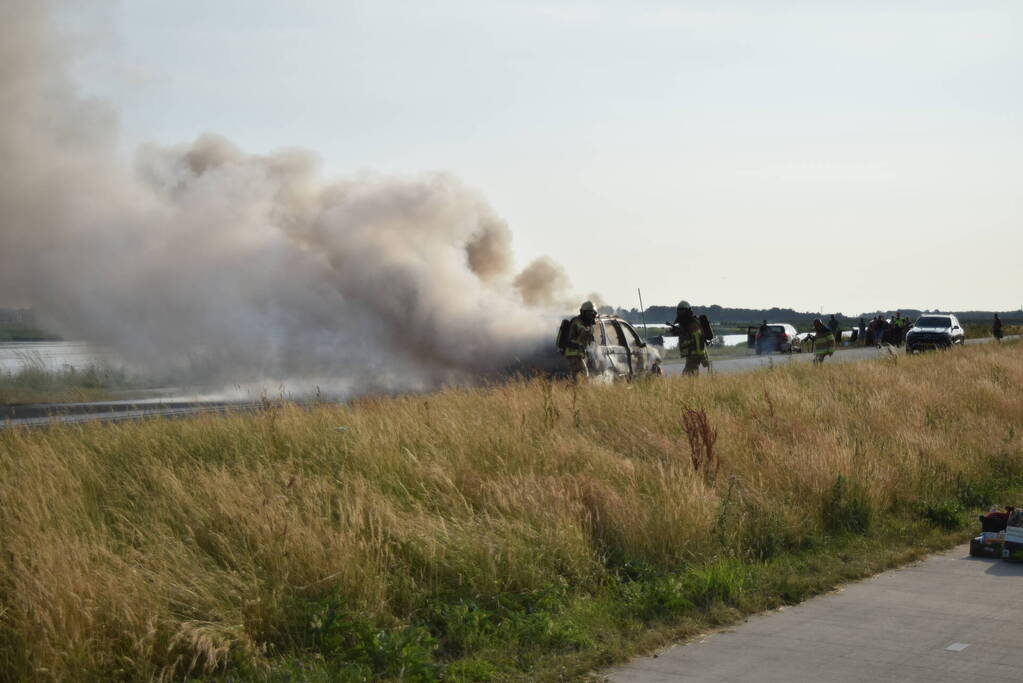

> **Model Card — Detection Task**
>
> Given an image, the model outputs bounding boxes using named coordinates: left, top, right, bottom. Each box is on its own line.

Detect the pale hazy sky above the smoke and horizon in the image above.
left=62, top=0, right=1023, bottom=313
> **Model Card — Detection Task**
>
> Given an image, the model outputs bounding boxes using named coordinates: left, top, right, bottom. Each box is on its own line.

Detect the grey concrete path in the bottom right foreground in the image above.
left=605, top=545, right=1023, bottom=683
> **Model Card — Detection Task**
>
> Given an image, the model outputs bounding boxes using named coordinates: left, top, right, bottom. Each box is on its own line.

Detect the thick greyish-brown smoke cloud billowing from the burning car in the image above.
left=0, top=0, right=581, bottom=392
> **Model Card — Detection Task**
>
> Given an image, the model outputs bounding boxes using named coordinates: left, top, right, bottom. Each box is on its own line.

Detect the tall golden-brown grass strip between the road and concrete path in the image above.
left=0, top=343, right=1023, bottom=682
